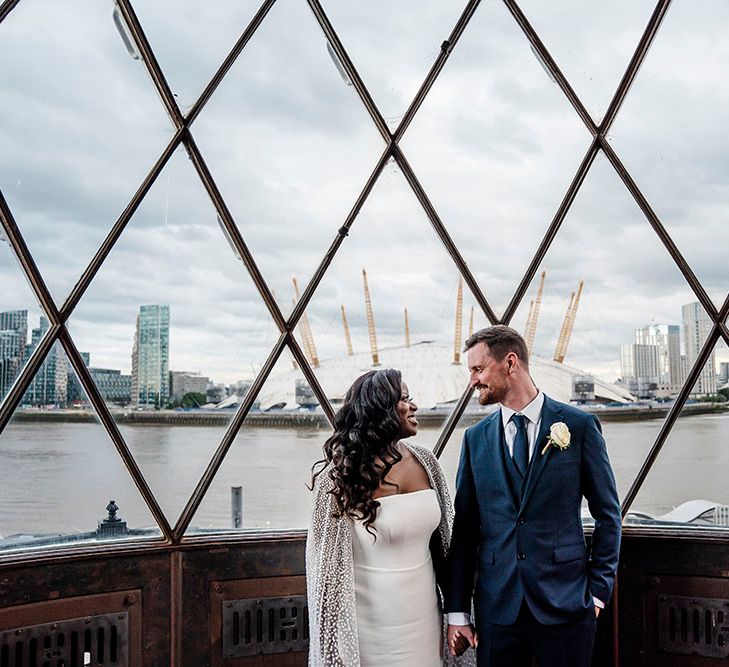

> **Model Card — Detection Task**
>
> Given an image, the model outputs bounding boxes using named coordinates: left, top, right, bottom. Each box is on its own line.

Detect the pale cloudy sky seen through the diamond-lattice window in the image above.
left=0, top=0, right=729, bottom=392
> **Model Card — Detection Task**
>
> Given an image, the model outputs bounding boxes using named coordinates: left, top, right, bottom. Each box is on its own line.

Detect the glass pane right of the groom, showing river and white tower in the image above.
left=626, top=348, right=729, bottom=529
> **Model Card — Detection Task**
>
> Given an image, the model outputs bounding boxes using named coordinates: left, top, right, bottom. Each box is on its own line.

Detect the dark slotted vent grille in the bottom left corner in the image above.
left=0, top=612, right=129, bottom=667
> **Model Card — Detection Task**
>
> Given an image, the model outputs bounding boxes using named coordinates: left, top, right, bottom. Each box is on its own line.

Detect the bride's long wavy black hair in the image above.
left=312, top=368, right=402, bottom=535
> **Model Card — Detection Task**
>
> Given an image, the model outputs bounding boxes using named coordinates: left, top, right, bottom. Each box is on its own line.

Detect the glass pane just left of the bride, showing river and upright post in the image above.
left=187, top=350, right=330, bottom=535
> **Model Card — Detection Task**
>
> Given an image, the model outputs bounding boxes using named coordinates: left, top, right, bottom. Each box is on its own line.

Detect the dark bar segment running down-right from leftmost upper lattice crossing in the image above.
left=183, top=130, right=287, bottom=332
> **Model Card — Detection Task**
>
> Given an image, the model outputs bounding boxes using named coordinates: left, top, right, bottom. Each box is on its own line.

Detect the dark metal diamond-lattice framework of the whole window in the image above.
left=0, top=0, right=729, bottom=545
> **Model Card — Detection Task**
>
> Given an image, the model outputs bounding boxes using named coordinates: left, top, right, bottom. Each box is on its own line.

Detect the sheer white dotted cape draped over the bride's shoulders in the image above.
left=306, top=443, right=475, bottom=667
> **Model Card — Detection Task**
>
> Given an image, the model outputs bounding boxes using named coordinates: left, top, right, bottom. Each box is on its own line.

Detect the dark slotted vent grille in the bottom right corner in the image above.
left=658, top=595, right=729, bottom=658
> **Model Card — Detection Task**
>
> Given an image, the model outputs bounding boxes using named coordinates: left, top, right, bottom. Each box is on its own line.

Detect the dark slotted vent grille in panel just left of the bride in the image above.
left=223, top=595, right=309, bottom=658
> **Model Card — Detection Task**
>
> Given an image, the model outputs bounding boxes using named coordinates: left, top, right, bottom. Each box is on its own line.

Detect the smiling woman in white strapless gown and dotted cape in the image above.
left=306, top=369, right=472, bottom=667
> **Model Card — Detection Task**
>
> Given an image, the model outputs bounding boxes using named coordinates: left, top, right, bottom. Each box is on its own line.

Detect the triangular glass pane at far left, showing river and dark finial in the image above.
left=0, top=354, right=161, bottom=554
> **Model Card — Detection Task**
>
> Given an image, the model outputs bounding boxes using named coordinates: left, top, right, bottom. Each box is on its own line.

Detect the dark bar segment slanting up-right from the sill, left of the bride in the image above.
left=172, top=333, right=289, bottom=544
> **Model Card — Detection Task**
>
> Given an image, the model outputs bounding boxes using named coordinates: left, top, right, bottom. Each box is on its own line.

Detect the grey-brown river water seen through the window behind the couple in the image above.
left=0, top=414, right=729, bottom=537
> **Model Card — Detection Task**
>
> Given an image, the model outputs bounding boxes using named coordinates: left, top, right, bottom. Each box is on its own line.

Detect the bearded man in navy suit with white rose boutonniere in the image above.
left=446, top=325, right=621, bottom=667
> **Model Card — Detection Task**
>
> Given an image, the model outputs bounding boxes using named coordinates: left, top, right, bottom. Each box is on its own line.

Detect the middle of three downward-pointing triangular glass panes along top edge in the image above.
left=322, top=0, right=466, bottom=130
